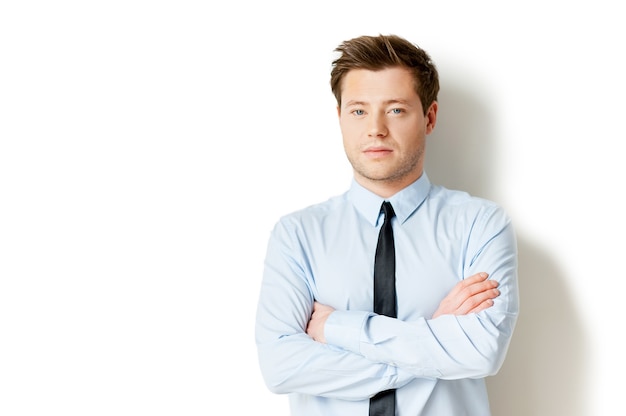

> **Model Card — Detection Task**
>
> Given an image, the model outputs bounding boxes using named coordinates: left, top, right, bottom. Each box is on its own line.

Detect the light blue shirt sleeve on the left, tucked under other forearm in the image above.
left=255, top=222, right=414, bottom=400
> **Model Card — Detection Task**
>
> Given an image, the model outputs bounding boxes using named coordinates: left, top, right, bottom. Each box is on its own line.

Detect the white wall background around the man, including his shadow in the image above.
left=0, top=0, right=626, bottom=416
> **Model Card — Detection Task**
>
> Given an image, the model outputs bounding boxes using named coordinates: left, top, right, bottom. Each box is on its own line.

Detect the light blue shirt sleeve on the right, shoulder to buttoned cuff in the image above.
left=324, top=205, right=519, bottom=379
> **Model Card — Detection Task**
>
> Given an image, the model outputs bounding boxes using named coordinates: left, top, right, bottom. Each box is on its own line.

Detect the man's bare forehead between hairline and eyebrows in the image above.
left=341, top=67, right=419, bottom=102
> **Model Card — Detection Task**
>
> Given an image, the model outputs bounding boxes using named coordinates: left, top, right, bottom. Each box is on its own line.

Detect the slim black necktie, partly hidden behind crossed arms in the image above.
left=369, top=201, right=397, bottom=416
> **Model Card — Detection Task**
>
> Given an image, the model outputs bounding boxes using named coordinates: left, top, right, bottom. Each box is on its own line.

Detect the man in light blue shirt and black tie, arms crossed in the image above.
left=256, top=35, right=519, bottom=416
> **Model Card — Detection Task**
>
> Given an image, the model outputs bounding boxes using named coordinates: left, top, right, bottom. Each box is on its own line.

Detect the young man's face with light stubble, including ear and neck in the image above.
left=337, top=67, right=437, bottom=197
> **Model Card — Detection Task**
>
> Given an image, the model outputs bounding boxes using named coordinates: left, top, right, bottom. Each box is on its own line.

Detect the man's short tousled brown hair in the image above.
left=330, top=35, right=439, bottom=114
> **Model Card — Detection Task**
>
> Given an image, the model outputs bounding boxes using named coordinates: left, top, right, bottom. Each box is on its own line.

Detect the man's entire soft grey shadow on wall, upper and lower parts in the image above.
left=426, top=84, right=588, bottom=416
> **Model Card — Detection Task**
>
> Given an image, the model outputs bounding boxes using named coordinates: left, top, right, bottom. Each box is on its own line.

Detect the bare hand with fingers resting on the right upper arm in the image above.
left=433, top=272, right=500, bottom=318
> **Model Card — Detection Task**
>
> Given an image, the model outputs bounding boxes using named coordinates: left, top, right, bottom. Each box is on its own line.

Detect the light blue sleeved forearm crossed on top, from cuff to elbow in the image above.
left=326, top=311, right=510, bottom=379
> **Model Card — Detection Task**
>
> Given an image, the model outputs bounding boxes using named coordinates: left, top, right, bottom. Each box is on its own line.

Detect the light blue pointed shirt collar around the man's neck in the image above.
left=348, top=172, right=431, bottom=226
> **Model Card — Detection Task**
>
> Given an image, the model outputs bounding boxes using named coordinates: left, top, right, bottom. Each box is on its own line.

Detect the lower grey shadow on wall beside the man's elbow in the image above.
left=487, top=237, right=589, bottom=416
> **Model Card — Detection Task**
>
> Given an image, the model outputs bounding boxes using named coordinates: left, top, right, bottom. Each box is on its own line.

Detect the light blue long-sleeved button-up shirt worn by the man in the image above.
left=256, top=173, right=519, bottom=416
